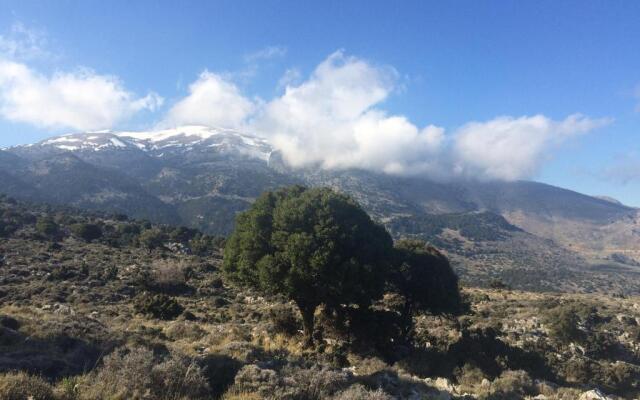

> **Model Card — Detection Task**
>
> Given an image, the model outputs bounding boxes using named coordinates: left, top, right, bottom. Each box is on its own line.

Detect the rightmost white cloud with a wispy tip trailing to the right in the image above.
left=452, top=114, right=609, bottom=180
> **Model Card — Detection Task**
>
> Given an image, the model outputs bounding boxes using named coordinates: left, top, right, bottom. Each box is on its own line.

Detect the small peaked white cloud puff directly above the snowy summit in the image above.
left=161, top=71, right=255, bottom=128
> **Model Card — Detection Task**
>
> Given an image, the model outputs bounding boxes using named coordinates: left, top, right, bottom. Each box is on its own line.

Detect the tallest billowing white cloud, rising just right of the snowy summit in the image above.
left=253, top=52, right=440, bottom=173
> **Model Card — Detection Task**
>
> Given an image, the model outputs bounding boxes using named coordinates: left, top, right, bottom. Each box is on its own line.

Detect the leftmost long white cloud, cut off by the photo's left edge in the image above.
left=0, top=59, right=162, bottom=130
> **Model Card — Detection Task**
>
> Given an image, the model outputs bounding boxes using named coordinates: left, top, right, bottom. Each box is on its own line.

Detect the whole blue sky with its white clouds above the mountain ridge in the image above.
left=0, top=0, right=640, bottom=207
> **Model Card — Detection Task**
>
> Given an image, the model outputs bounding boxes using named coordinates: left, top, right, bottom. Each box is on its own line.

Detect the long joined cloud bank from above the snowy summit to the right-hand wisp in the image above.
left=166, top=51, right=610, bottom=180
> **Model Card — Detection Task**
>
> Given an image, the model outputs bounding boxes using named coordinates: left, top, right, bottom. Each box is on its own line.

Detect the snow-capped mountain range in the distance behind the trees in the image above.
left=0, top=126, right=640, bottom=293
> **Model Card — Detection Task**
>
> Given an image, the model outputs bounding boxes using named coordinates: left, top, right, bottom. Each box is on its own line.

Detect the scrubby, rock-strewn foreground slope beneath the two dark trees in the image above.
left=0, top=193, right=640, bottom=400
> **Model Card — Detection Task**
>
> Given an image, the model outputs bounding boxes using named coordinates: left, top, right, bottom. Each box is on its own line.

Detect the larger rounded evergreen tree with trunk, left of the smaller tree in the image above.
left=223, top=186, right=393, bottom=344
